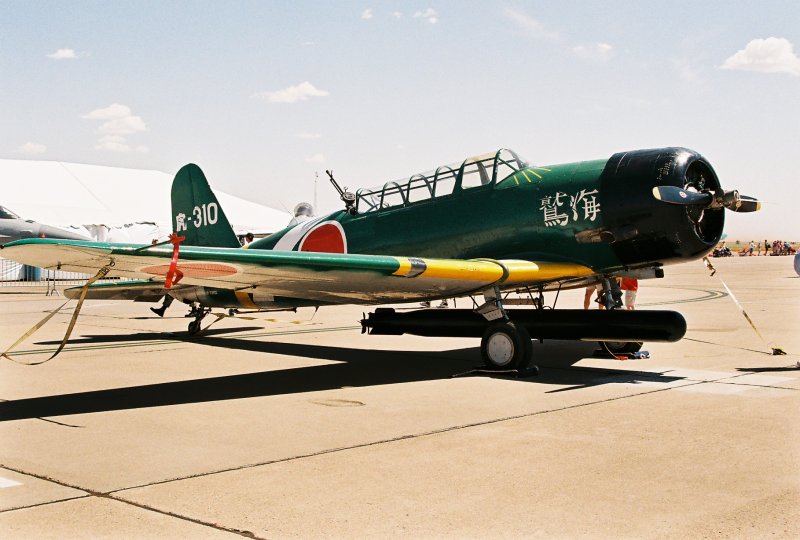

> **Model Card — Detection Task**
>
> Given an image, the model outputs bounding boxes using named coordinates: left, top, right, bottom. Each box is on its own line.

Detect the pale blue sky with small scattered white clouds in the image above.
left=0, top=0, right=800, bottom=239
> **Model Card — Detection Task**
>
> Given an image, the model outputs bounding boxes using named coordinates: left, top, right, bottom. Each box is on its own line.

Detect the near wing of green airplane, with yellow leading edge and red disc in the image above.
left=0, top=239, right=594, bottom=304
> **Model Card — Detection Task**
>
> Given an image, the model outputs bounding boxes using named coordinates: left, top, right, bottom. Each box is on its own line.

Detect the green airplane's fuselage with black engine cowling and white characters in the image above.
left=249, top=148, right=724, bottom=273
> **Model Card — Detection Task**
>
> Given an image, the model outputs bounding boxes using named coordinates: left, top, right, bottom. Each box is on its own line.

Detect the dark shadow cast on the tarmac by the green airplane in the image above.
left=0, top=328, right=680, bottom=421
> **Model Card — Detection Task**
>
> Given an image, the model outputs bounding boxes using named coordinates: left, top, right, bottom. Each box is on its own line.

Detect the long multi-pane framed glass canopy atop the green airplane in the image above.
left=356, top=148, right=530, bottom=214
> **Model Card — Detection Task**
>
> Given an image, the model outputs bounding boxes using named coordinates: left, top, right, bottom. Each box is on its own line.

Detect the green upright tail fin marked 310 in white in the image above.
left=172, top=163, right=240, bottom=247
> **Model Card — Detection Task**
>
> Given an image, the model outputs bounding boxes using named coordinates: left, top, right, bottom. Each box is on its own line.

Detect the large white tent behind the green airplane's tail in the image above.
left=0, top=159, right=292, bottom=243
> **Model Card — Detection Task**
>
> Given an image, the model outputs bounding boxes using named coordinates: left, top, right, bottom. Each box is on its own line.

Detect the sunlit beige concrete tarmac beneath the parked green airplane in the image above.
left=0, top=257, right=800, bottom=538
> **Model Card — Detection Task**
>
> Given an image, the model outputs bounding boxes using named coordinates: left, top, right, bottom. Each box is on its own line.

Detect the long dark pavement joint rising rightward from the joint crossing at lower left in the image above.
left=108, top=381, right=713, bottom=494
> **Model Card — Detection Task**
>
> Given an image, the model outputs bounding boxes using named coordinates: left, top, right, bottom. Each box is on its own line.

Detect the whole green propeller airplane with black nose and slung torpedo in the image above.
left=2, top=148, right=760, bottom=368
